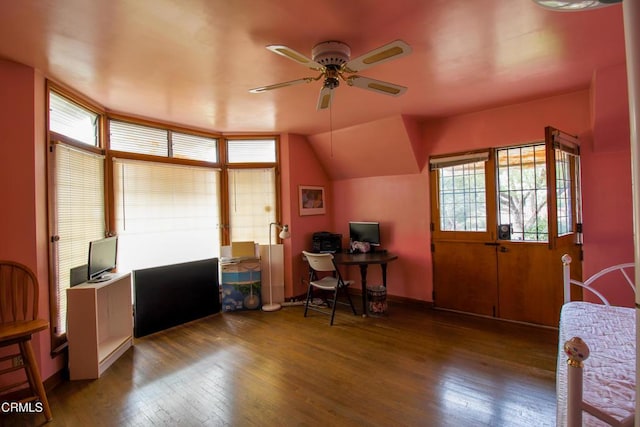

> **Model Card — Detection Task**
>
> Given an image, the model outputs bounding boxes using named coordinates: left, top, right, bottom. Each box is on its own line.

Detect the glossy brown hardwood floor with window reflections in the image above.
left=0, top=303, right=557, bottom=427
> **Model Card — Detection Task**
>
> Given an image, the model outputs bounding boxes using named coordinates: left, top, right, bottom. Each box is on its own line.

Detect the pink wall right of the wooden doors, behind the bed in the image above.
left=582, top=64, right=634, bottom=307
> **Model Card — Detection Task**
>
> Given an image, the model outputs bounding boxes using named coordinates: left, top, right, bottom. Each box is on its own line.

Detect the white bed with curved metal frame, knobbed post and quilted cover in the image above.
left=556, top=255, right=635, bottom=427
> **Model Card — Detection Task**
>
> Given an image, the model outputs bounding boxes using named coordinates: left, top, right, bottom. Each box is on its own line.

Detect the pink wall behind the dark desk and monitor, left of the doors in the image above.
left=332, top=174, right=433, bottom=301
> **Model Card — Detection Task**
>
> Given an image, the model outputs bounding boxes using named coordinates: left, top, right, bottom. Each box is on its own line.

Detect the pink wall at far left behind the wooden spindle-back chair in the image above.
left=0, top=60, right=62, bottom=379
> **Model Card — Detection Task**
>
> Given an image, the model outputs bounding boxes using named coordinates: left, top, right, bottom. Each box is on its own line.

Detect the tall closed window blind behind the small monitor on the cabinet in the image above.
left=54, top=144, right=105, bottom=335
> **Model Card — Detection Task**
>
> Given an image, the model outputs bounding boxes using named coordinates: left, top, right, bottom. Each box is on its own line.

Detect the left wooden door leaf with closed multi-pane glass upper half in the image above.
left=430, top=152, right=498, bottom=316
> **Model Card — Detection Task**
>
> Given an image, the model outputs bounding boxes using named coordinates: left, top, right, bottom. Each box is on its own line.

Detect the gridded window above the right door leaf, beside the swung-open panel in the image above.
left=497, top=143, right=549, bottom=242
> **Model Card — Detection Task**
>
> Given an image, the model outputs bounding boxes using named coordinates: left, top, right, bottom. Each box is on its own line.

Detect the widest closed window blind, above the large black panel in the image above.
left=114, top=159, right=220, bottom=271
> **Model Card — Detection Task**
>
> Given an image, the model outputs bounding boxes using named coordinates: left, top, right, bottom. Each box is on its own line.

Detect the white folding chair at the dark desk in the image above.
left=302, top=251, right=356, bottom=325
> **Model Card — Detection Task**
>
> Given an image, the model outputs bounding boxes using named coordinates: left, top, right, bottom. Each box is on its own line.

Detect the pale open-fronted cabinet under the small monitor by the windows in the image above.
left=67, top=273, right=133, bottom=380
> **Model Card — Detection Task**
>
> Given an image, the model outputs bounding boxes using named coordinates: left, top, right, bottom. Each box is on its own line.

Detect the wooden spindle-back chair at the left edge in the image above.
left=0, top=260, right=52, bottom=421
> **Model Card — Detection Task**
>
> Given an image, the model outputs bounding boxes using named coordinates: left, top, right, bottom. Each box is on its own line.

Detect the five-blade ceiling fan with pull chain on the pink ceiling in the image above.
left=249, top=40, right=411, bottom=110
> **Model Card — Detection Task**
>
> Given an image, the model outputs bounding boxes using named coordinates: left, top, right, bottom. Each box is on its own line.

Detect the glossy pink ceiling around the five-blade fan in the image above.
left=0, top=0, right=624, bottom=137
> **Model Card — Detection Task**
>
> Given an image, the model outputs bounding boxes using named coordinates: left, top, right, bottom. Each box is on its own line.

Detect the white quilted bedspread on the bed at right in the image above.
left=556, top=302, right=636, bottom=426
